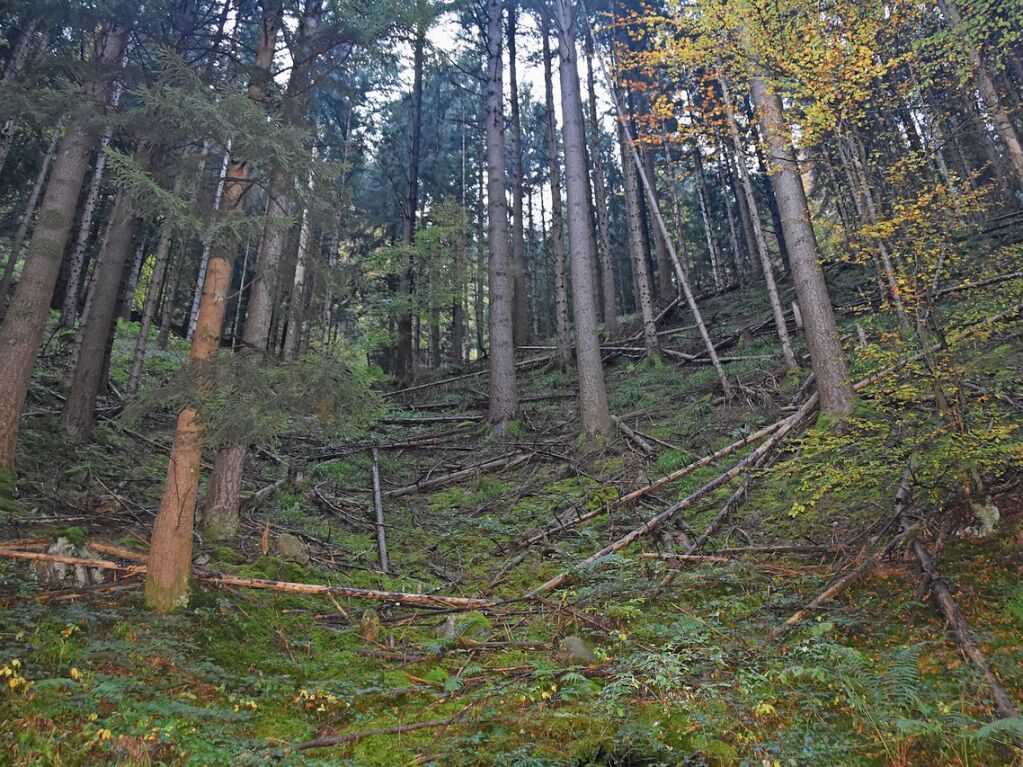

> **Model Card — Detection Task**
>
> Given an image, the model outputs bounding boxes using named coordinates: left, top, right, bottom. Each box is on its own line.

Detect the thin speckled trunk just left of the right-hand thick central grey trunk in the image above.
left=540, top=18, right=572, bottom=372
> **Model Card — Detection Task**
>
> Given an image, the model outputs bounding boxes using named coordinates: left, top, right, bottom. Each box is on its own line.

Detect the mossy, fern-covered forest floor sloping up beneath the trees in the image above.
left=0, top=263, right=1023, bottom=766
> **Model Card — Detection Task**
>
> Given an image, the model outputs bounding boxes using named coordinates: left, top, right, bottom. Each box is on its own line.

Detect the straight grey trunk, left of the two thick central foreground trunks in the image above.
left=486, top=0, right=519, bottom=433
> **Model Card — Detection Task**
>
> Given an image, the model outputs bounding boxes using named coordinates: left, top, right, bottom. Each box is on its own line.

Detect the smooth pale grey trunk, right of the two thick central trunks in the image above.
left=554, top=0, right=612, bottom=437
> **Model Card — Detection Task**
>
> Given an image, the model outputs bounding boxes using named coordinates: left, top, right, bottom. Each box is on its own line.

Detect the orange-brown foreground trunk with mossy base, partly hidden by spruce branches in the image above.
left=145, top=0, right=282, bottom=613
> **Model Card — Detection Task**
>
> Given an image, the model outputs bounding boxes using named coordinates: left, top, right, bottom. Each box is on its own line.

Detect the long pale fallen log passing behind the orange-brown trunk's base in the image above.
left=0, top=548, right=497, bottom=610
